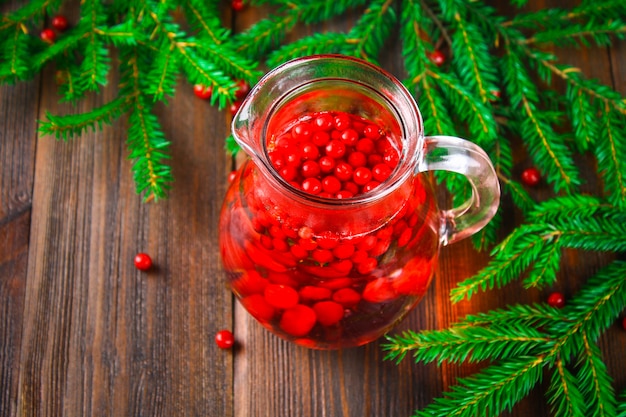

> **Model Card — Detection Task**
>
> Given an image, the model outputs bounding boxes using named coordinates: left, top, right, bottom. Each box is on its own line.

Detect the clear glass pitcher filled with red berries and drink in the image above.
left=219, top=55, right=500, bottom=349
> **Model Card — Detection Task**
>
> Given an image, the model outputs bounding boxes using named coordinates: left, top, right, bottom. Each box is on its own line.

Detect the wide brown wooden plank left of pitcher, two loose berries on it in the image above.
left=15, top=53, right=232, bottom=416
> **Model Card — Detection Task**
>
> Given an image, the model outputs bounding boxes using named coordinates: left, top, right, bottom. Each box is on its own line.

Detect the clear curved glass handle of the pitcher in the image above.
left=417, top=136, right=500, bottom=245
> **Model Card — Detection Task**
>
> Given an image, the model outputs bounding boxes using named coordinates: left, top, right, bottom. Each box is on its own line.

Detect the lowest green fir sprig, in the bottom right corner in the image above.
left=384, top=261, right=626, bottom=417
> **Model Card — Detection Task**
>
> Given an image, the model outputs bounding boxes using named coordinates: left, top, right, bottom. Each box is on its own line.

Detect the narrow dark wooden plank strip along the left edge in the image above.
left=0, top=77, right=39, bottom=416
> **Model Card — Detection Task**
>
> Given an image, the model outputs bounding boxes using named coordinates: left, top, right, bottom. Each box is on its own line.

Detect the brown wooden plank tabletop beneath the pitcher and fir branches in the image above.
left=0, top=0, right=626, bottom=417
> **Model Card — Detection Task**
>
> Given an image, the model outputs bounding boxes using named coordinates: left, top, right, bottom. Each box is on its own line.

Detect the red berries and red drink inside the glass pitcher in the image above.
left=220, top=111, right=438, bottom=349
